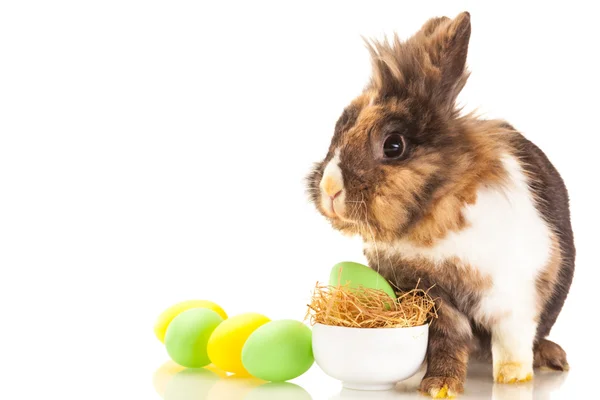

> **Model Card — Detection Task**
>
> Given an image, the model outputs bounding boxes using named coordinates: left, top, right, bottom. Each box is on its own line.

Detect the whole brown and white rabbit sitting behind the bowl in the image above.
left=308, top=12, right=575, bottom=396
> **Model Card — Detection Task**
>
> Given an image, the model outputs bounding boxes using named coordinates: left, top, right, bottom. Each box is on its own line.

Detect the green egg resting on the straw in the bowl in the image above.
left=329, top=261, right=396, bottom=299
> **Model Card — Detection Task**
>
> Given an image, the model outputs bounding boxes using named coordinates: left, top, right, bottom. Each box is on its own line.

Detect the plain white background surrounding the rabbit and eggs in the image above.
left=0, top=0, right=600, bottom=400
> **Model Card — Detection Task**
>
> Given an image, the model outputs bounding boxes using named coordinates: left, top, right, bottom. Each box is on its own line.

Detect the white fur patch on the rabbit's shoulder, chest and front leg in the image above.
left=376, top=155, right=552, bottom=378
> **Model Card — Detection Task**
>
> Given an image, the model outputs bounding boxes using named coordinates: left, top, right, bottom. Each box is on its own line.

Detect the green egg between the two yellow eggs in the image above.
left=165, top=308, right=223, bottom=368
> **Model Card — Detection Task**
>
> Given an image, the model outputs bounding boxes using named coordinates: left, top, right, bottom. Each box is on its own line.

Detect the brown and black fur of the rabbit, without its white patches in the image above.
left=308, top=13, right=575, bottom=394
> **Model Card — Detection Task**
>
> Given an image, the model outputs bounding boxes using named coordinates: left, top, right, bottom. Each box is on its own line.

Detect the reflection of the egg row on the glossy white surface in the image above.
left=154, top=362, right=311, bottom=400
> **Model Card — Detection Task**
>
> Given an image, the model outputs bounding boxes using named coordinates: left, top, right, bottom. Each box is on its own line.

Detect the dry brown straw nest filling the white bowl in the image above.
left=306, top=282, right=437, bottom=328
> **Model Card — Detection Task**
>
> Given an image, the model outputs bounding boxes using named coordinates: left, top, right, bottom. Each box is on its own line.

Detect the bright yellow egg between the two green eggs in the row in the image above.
left=208, top=313, right=270, bottom=375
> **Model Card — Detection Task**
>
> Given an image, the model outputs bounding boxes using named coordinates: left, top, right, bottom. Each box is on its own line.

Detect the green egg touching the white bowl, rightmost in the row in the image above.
left=242, top=320, right=315, bottom=382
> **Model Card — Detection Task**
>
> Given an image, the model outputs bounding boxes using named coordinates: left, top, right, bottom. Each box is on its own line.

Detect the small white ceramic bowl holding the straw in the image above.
left=312, top=324, right=429, bottom=390
